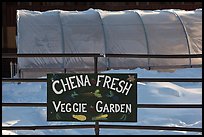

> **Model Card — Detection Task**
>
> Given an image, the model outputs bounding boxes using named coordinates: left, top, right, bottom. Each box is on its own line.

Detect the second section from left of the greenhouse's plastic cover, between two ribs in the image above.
left=60, top=10, right=105, bottom=70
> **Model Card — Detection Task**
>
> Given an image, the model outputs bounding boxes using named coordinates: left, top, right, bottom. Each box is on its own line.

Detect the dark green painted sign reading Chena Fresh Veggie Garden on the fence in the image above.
left=47, top=73, right=137, bottom=122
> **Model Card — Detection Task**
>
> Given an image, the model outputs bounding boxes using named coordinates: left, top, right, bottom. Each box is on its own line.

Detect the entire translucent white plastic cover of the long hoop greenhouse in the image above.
left=17, top=9, right=202, bottom=77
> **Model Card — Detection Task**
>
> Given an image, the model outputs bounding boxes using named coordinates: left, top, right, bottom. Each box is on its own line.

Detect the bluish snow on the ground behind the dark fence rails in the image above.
left=2, top=68, right=202, bottom=135
